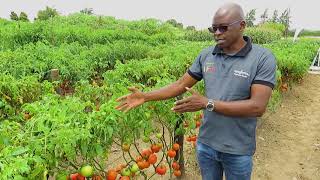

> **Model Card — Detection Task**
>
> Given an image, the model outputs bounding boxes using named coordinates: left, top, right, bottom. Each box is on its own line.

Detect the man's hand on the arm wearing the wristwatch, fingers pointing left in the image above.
left=171, top=87, right=208, bottom=113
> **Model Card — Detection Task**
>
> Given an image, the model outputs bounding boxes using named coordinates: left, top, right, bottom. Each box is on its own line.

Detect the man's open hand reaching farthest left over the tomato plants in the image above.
left=116, top=87, right=145, bottom=112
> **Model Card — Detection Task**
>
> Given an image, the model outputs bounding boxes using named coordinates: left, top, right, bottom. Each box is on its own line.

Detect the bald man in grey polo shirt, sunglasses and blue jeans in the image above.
left=116, top=3, right=276, bottom=180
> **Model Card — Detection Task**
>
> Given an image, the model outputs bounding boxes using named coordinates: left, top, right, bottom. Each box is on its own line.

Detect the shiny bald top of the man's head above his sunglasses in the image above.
left=214, top=3, right=244, bottom=22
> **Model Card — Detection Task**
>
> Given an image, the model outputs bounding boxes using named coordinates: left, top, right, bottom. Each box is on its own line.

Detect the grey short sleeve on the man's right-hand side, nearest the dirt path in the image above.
left=252, top=53, right=277, bottom=89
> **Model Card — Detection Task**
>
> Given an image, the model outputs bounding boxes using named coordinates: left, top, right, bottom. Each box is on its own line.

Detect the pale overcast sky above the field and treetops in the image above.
left=0, top=0, right=320, bottom=30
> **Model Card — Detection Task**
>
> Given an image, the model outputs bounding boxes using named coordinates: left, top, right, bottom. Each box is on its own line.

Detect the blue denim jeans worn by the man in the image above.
left=197, top=142, right=253, bottom=180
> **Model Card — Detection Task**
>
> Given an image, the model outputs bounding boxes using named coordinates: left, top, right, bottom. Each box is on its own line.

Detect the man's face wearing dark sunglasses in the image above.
left=212, top=16, right=245, bottom=48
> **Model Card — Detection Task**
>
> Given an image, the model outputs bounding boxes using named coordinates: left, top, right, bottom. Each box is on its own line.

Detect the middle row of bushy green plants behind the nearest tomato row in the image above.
left=0, top=41, right=154, bottom=81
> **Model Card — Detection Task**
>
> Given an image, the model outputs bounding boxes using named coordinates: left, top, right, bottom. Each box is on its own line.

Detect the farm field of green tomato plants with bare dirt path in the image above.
left=0, top=14, right=320, bottom=180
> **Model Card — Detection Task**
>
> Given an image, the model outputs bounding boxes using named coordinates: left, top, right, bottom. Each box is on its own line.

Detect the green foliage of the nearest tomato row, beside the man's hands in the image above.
left=1, top=41, right=210, bottom=178
